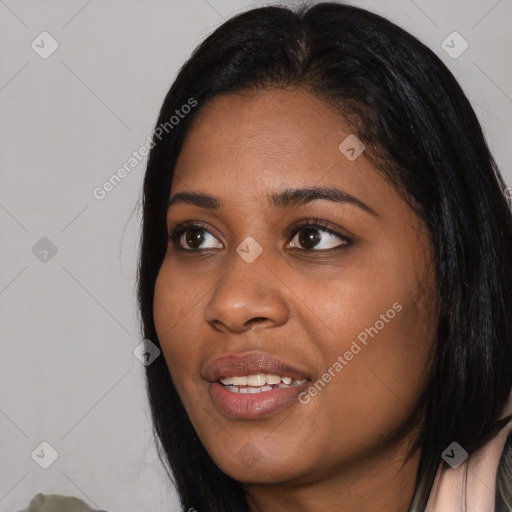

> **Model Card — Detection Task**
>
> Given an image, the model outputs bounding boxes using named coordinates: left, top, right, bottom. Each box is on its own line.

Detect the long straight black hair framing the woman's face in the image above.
left=138, top=2, right=512, bottom=512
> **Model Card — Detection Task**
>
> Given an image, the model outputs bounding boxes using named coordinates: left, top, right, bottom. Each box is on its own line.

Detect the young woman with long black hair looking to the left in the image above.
left=139, top=3, right=512, bottom=512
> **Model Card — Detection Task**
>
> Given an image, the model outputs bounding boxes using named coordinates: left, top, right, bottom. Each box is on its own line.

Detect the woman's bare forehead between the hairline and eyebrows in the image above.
left=172, top=90, right=389, bottom=210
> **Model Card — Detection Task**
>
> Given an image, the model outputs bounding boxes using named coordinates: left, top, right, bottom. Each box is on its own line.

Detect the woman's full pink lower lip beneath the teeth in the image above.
left=208, top=380, right=310, bottom=420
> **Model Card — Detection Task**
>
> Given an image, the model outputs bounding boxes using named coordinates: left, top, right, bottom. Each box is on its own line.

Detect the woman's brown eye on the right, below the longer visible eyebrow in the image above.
left=287, top=220, right=352, bottom=252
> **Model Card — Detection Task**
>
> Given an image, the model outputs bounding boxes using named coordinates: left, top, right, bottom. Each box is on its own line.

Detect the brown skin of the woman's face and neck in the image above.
left=154, top=89, right=437, bottom=512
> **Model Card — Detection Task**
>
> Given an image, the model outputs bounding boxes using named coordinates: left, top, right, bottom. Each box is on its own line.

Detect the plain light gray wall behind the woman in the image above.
left=0, top=0, right=512, bottom=512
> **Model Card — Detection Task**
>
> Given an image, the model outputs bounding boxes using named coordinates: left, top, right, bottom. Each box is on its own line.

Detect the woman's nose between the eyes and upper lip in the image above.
left=205, top=246, right=289, bottom=333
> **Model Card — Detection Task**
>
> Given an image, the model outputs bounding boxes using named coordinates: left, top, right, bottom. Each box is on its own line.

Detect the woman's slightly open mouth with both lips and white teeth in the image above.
left=205, top=352, right=311, bottom=420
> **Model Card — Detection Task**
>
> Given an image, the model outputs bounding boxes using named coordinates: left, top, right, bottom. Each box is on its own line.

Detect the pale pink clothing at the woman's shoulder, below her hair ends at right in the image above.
left=425, top=392, right=512, bottom=512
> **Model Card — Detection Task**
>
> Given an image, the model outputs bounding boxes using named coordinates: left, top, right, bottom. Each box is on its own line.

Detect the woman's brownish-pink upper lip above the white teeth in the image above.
left=204, top=352, right=311, bottom=382
